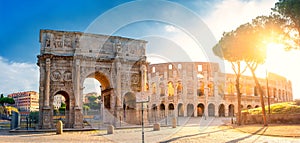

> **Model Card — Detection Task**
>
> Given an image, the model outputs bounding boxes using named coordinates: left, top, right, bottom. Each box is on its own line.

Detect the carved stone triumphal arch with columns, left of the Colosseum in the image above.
left=38, top=30, right=148, bottom=129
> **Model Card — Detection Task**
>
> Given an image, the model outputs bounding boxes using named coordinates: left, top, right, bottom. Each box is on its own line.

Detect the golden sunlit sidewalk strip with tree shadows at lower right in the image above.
left=231, top=124, right=300, bottom=137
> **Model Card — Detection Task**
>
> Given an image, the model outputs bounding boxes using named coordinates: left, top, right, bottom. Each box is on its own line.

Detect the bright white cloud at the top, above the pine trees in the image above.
left=203, top=0, right=277, bottom=39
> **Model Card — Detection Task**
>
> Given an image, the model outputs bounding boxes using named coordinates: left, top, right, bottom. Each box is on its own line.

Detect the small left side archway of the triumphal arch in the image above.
left=50, top=90, right=73, bottom=128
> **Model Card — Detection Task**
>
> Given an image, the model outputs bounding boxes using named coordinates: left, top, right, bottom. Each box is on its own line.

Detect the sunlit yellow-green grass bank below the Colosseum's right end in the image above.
left=242, top=102, right=300, bottom=115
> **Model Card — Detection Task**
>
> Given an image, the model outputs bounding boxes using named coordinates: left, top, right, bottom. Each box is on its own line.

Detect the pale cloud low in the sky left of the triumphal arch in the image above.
left=0, top=57, right=39, bottom=95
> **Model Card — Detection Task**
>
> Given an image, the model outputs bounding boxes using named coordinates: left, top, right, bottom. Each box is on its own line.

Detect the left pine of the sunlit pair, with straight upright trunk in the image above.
left=213, top=29, right=246, bottom=125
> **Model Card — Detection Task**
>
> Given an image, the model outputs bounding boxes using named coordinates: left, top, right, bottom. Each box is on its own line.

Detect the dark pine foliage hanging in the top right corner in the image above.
left=272, top=0, right=300, bottom=49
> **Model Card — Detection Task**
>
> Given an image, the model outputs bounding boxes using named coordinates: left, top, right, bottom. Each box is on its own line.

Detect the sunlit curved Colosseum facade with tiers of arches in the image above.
left=146, top=62, right=293, bottom=120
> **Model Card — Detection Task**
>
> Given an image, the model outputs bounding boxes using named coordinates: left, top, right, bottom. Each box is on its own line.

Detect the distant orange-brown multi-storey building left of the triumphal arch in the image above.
left=8, top=91, right=39, bottom=115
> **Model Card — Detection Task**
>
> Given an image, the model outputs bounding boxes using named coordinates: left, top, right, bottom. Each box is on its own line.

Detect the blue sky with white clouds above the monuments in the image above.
left=0, top=0, right=300, bottom=98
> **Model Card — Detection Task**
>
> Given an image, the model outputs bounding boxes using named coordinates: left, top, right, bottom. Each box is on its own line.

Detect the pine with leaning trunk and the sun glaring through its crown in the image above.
left=243, top=15, right=287, bottom=126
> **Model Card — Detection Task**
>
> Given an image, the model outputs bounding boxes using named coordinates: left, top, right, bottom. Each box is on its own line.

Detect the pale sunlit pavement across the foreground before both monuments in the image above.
left=0, top=118, right=300, bottom=143
